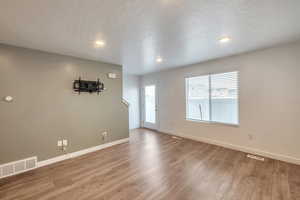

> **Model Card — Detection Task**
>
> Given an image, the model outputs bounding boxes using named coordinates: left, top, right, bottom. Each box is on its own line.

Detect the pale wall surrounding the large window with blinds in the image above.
left=141, top=42, right=300, bottom=164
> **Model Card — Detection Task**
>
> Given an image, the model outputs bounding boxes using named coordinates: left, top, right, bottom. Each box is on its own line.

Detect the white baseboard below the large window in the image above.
left=160, top=131, right=300, bottom=165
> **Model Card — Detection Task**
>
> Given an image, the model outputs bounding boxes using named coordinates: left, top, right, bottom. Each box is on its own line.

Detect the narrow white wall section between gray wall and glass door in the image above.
left=123, top=74, right=140, bottom=129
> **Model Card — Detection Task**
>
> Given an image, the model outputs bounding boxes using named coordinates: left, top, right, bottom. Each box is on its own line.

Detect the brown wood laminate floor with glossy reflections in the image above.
left=0, top=129, right=300, bottom=200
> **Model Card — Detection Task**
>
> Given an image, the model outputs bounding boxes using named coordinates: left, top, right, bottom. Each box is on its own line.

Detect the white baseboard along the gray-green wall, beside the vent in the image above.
left=37, top=138, right=129, bottom=167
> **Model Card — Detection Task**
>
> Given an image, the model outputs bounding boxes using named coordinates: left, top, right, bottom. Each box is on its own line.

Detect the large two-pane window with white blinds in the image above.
left=185, top=71, right=239, bottom=125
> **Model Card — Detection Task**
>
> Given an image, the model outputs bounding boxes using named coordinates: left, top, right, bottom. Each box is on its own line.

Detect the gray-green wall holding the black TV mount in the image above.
left=0, top=45, right=129, bottom=164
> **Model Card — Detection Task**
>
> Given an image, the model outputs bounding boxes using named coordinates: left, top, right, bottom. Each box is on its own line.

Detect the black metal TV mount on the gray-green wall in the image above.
left=73, top=77, right=104, bottom=95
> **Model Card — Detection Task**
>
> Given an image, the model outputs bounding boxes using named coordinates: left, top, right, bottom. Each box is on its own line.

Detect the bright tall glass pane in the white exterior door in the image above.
left=145, top=85, right=156, bottom=124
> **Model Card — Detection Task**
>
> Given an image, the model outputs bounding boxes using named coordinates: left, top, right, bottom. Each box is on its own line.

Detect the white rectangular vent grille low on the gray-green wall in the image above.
left=0, top=157, right=37, bottom=178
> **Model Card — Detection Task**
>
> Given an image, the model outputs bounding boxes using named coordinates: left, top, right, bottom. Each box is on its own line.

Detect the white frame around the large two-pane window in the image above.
left=184, top=70, right=240, bottom=127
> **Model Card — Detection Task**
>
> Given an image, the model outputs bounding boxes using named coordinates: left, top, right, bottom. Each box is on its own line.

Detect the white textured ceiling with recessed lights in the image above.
left=0, top=0, right=300, bottom=74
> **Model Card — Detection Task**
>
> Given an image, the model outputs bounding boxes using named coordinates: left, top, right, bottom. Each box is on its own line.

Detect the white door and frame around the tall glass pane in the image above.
left=141, top=83, right=159, bottom=130
